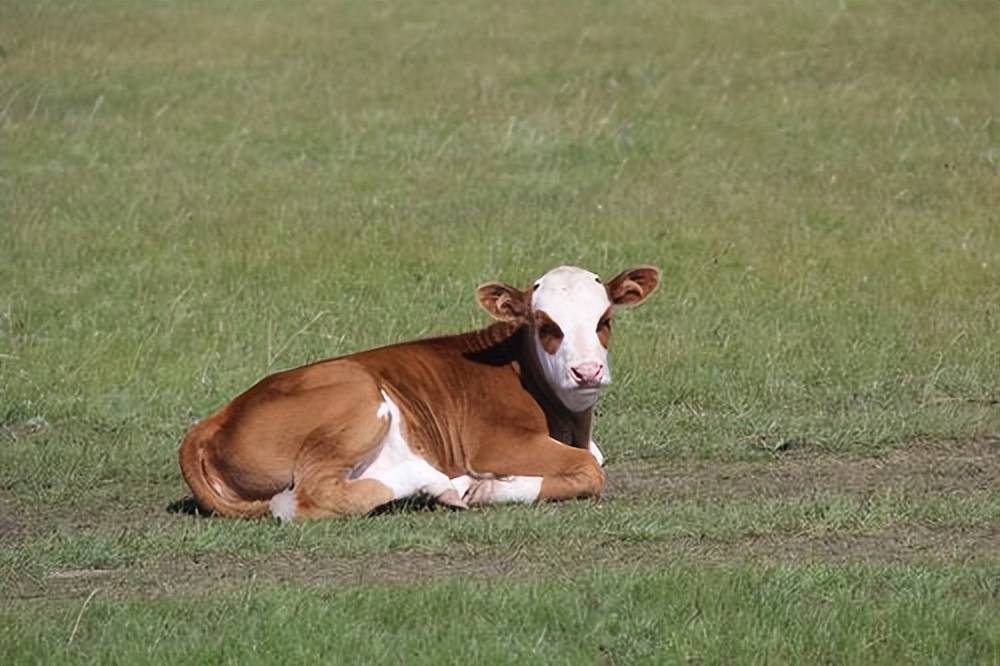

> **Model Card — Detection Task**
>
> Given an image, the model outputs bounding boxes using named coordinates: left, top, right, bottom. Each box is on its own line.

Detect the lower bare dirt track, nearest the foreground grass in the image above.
left=12, top=529, right=1000, bottom=601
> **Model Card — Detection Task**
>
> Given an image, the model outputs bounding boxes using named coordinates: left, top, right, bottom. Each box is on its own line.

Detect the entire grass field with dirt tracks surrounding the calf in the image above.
left=0, top=0, right=1000, bottom=664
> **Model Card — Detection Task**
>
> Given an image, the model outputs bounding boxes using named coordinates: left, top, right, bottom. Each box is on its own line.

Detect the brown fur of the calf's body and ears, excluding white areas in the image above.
left=180, top=267, right=659, bottom=518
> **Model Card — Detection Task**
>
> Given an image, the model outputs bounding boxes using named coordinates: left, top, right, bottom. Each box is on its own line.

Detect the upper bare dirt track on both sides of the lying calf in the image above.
left=17, top=435, right=1000, bottom=542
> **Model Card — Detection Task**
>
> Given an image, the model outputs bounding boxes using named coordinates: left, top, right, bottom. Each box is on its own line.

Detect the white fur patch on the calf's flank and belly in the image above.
left=348, top=391, right=461, bottom=499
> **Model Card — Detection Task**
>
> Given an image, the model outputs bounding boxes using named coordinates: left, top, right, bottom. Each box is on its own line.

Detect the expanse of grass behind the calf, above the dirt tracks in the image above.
left=0, top=2, right=1000, bottom=478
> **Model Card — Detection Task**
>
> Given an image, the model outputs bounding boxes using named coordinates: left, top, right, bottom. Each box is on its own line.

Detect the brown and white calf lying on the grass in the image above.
left=180, top=266, right=660, bottom=520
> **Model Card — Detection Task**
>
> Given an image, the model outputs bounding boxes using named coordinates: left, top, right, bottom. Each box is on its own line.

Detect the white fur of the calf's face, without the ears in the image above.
left=531, top=266, right=611, bottom=412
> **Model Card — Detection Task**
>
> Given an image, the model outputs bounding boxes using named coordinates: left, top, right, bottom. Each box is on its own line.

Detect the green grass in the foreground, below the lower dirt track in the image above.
left=0, top=565, right=1000, bottom=664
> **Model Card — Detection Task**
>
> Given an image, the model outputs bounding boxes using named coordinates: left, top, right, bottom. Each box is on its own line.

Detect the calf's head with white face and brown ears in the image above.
left=477, top=266, right=660, bottom=412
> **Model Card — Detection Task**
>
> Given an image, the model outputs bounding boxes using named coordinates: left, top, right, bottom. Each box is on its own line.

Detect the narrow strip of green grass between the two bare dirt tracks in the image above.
left=0, top=489, right=1000, bottom=589
